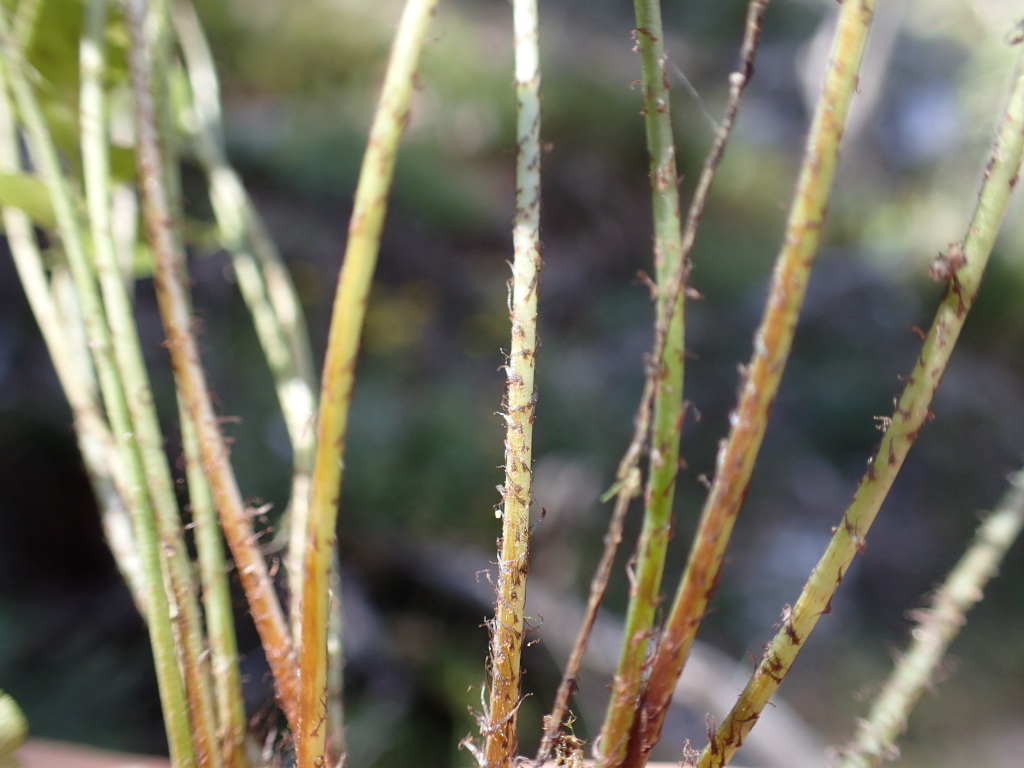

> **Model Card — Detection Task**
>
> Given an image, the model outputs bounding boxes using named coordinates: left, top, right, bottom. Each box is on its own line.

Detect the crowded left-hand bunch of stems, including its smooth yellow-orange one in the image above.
left=0, top=0, right=436, bottom=768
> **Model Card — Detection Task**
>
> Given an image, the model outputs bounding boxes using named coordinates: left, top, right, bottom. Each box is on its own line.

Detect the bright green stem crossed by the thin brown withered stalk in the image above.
left=594, top=0, right=686, bottom=768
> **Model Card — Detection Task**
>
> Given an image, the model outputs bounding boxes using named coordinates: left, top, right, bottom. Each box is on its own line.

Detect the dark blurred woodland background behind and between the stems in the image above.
left=0, top=0, right=1024, bottom=768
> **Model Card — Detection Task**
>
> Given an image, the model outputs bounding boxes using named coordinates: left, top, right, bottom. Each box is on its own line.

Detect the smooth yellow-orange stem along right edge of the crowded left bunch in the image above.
left=295, top=0, right=437, bottom=768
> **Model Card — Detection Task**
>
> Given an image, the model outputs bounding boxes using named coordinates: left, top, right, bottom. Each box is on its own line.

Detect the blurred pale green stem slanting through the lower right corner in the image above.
left=839, top=472, right=1024, bottom=768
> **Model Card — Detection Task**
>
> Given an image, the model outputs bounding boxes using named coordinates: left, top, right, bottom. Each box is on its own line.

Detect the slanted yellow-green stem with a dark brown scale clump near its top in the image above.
left=700, top=41, right=1024, bottom=768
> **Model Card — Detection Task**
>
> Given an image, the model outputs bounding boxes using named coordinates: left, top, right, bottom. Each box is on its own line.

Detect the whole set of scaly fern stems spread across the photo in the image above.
left=0, top=0, right=1024, bottom=768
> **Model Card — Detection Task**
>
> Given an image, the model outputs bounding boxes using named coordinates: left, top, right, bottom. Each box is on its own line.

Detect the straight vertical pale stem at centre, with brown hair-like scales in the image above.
left=481, top=0, right=542, bottom=768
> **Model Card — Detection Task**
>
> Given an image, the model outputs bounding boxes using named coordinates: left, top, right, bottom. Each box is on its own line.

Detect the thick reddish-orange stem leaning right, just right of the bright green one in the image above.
left=636, top=0, right=874, bottom=765
